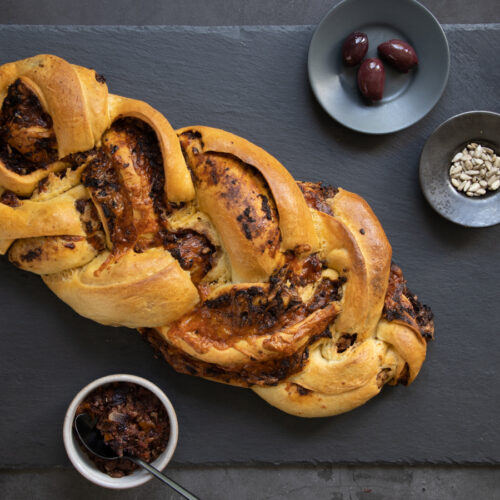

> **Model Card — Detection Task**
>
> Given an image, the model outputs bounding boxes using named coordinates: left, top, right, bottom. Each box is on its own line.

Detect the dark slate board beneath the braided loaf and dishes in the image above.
left=0, top=25, right=500, bottom=466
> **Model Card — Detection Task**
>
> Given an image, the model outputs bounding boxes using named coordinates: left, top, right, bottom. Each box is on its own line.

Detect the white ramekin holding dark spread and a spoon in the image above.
left=63, top=374, right=179, bottom=490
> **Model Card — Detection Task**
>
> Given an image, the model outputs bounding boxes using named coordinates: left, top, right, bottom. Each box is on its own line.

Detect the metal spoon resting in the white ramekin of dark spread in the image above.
left=73, top=413, right=199, bottom=500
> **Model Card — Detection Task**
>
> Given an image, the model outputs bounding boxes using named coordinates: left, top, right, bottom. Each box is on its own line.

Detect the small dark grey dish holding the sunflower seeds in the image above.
left=420, top=111, right=500, bottom=227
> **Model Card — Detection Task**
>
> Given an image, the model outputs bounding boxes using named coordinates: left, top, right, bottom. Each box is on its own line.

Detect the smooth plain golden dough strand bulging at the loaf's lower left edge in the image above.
left=43, top=248, right=199, bottom=328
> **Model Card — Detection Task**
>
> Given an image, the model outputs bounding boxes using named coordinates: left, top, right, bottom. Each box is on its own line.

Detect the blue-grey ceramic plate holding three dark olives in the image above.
left=308, top=0, right=450, bottom=134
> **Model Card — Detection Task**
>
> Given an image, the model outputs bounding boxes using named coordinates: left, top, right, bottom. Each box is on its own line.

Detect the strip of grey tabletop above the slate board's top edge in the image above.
left=1, top=0, right=499, bottom=26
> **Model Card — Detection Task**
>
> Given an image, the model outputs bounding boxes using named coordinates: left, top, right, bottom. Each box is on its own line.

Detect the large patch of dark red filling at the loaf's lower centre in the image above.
left=169, top=254, right=345, bottom=352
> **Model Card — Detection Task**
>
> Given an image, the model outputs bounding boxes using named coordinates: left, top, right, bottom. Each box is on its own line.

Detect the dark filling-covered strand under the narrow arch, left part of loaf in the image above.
left=82, top=118, right=216, bottom=283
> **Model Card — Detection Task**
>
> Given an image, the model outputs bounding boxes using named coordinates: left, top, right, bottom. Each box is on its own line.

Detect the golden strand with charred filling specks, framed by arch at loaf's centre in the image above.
left=179, top=131, right=284, bottom=282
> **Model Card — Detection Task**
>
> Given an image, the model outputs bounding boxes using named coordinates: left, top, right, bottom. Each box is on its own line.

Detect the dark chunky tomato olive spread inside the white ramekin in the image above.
left=76, top=382, right=170, bottom=477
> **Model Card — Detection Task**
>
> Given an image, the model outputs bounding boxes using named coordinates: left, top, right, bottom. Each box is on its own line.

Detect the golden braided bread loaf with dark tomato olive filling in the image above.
left=0, top=55, right=434, bottom=417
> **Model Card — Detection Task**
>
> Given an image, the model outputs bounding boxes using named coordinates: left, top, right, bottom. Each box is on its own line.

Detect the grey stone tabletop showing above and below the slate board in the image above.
left=0, top=0, right=500, bottom=500
